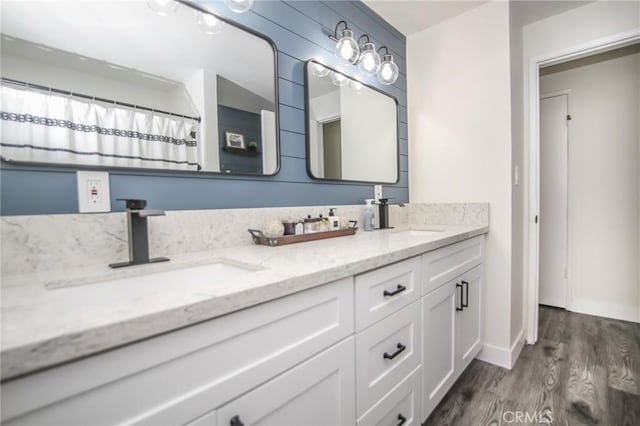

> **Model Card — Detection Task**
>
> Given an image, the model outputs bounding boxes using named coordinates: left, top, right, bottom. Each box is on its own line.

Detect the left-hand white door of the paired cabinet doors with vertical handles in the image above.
left=422, top=280, right=458, bottom=421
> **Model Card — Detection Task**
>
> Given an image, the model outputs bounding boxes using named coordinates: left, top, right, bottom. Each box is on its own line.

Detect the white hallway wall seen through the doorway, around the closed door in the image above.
left=540, top=46, right=640, bottom=321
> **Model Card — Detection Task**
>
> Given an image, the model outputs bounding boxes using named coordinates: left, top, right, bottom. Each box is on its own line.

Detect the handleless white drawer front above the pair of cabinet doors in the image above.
left=422, top=235, right=484, bottom=295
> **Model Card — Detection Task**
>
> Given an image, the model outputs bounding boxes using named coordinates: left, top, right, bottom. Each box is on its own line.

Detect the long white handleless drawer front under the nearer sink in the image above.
left=2, top=278, right=354, bottom=426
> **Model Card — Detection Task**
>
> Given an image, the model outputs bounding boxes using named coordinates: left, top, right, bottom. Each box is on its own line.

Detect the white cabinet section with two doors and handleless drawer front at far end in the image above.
left=422, top=236, right=484, bottom=421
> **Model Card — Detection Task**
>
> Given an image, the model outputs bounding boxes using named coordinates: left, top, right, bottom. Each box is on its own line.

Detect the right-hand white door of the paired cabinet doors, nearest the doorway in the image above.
left=456, top=265, right=483, bottom=373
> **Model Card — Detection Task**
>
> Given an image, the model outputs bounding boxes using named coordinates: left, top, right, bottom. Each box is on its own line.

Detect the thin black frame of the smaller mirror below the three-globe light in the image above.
left=304, top=58, right=400, bottom=185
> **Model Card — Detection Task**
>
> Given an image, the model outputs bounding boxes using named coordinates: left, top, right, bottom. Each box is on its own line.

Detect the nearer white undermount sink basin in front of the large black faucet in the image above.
left=47, top=259, right=262, bottom=306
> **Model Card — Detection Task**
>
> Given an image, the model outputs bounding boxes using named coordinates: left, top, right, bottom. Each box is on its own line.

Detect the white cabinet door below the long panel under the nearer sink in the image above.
left=218, top=337, right=356, bottom=426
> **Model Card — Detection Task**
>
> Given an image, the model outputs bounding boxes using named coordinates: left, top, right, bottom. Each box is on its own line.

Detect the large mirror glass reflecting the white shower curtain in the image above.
left=0, top=1, right=279, bottom=175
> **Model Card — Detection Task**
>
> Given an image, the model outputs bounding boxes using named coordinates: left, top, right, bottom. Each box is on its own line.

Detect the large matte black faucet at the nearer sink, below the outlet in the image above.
left=109, top=198, right=169, bottom=268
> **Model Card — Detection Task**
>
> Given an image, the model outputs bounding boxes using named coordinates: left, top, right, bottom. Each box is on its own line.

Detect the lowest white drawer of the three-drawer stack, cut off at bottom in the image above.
left=358, top=367, right=422, bottom=426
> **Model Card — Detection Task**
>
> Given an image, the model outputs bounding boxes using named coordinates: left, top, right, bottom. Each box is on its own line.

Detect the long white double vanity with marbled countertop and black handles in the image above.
left=2, top=208, right=488, bottom=426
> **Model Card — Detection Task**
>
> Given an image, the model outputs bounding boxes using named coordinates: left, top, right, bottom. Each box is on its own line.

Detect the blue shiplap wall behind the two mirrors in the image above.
left=0, top=0, right=409, bottom=215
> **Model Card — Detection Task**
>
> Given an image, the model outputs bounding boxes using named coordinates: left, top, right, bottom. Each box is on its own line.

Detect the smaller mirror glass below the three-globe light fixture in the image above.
left=305, top=60, right=398, bottom=183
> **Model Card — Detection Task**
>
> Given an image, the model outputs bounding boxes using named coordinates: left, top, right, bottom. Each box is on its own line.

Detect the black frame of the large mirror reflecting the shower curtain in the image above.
left=0, top=0, right=282, bottom=178
